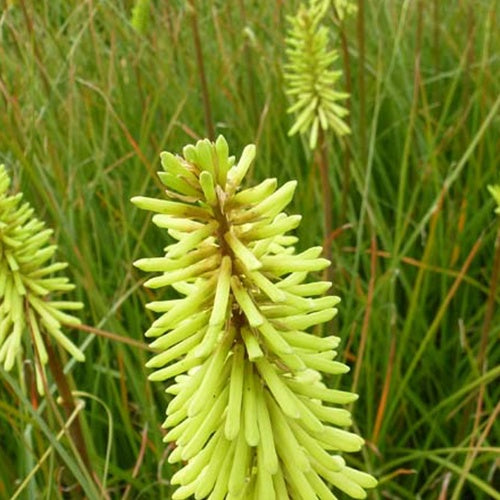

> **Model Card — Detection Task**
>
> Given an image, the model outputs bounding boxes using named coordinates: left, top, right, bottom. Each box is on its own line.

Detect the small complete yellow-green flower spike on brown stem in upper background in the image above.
left=284, top=1, right=350, bottom=150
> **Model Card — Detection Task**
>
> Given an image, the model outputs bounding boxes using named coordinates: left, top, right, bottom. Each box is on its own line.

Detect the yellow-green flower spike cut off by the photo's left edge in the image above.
left=0, top=165, right=85, bottom=393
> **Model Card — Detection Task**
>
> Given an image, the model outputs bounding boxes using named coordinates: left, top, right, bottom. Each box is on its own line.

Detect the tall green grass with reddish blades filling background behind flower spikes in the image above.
left=0, top=0, right=500, bottom=500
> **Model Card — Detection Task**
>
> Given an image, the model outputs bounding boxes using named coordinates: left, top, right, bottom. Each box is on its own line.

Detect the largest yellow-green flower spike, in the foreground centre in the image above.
left=132, top=136, right=376, bottom=500
